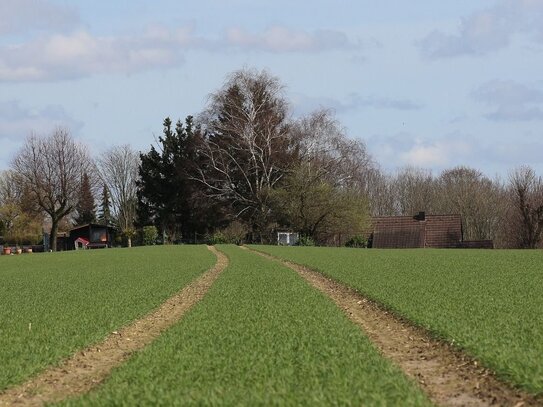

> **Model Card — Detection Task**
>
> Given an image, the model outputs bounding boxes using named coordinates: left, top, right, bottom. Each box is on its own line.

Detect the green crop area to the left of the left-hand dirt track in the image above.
left=0, top=246, right=216, bottom=391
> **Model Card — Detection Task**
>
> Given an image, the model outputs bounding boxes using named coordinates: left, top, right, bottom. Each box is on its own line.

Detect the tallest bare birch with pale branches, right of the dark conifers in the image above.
left=195, top=70, right=294, bottom=241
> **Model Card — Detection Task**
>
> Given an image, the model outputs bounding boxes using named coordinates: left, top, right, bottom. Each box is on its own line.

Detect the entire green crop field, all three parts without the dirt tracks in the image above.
left=0, top=245, right=543, bottom=405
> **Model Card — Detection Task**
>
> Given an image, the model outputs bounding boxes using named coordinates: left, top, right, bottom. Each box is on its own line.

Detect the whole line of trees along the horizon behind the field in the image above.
left=0, top=70, right=543, bottom=250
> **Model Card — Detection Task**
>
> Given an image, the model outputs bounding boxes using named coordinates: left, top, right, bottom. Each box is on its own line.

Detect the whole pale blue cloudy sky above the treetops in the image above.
left=0, top=0, right=543, bottom=177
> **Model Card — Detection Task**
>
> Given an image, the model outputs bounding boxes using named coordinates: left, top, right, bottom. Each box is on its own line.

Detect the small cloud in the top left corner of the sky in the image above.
left=0, top=0, right=79, bottom=34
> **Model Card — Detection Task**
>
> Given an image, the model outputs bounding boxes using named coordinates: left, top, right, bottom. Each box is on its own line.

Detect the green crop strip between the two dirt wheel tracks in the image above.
left=59, top=246, right=430, bottom=406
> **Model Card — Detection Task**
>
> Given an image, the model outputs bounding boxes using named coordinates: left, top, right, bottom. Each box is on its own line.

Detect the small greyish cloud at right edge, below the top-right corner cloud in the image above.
left=471, top=80, right=543, bottom=121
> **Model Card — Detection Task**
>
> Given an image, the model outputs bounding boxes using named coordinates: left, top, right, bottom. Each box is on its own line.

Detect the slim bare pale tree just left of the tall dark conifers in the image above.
left=98, top=144, right=140, bottom=247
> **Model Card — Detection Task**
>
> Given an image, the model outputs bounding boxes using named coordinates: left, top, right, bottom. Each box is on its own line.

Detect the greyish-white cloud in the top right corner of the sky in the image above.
left=419, top=0, right=543, bottom=58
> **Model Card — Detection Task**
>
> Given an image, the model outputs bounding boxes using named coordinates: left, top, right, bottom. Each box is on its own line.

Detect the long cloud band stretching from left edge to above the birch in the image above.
left=0, top=26, right=355, bottom=82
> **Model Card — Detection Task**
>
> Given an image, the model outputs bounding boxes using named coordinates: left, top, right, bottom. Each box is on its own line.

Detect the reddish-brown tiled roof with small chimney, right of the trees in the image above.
left=372, top=215, right=462, bottom=248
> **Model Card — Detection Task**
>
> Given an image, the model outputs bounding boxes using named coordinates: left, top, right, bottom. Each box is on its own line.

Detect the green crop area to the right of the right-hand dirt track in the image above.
left=253, top=246, right=543, bottom=394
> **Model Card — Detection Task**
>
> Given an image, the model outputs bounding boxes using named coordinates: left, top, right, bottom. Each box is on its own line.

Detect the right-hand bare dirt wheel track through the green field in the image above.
left=248, top=245, right=543, bottom=407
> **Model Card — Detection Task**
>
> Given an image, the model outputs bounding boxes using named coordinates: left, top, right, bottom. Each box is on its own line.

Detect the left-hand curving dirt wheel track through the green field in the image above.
left=0, top=246, right=228, bottom=406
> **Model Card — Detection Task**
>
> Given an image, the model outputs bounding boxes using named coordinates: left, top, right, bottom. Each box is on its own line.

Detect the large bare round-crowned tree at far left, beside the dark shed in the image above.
left=12, top=128, right=93, bottom=251
